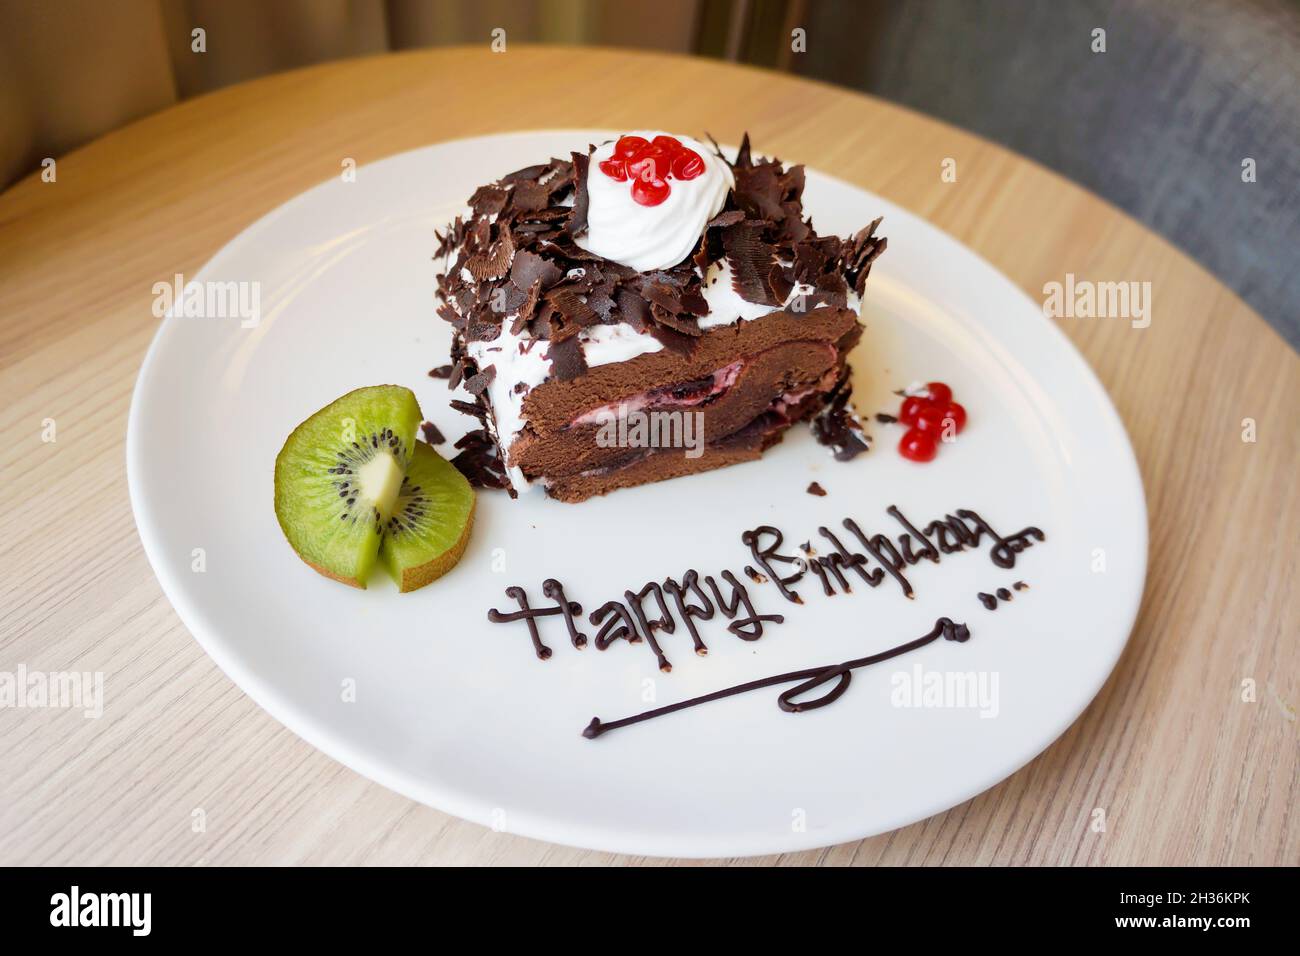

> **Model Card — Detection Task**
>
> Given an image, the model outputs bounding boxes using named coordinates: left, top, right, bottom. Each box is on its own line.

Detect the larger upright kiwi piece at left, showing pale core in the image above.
left=276, top=385, right=421, bottom=588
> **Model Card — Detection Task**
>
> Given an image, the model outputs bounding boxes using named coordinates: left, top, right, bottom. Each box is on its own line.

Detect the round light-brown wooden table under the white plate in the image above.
left=0, top=44, right=1300, bottom=864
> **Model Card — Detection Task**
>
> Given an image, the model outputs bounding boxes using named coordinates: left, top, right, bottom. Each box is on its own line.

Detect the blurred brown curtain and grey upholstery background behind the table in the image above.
left=0, top=0, right=1300, bottom=347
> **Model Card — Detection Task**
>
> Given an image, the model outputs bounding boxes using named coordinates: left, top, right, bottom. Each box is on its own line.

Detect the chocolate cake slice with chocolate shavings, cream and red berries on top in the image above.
left=437, top=133, right=885, bottom=502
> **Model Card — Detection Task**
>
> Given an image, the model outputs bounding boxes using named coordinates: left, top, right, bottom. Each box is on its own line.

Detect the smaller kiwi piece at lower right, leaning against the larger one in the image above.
left=380, top=441, right=475, bottom=591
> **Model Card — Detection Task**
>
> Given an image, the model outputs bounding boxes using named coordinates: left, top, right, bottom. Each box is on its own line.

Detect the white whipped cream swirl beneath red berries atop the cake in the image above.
left=575, top=130, right=736, bottom=272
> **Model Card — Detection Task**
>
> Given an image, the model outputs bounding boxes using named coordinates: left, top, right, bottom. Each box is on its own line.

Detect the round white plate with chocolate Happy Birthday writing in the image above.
left=127, top=131, right=1147, bottom=856
